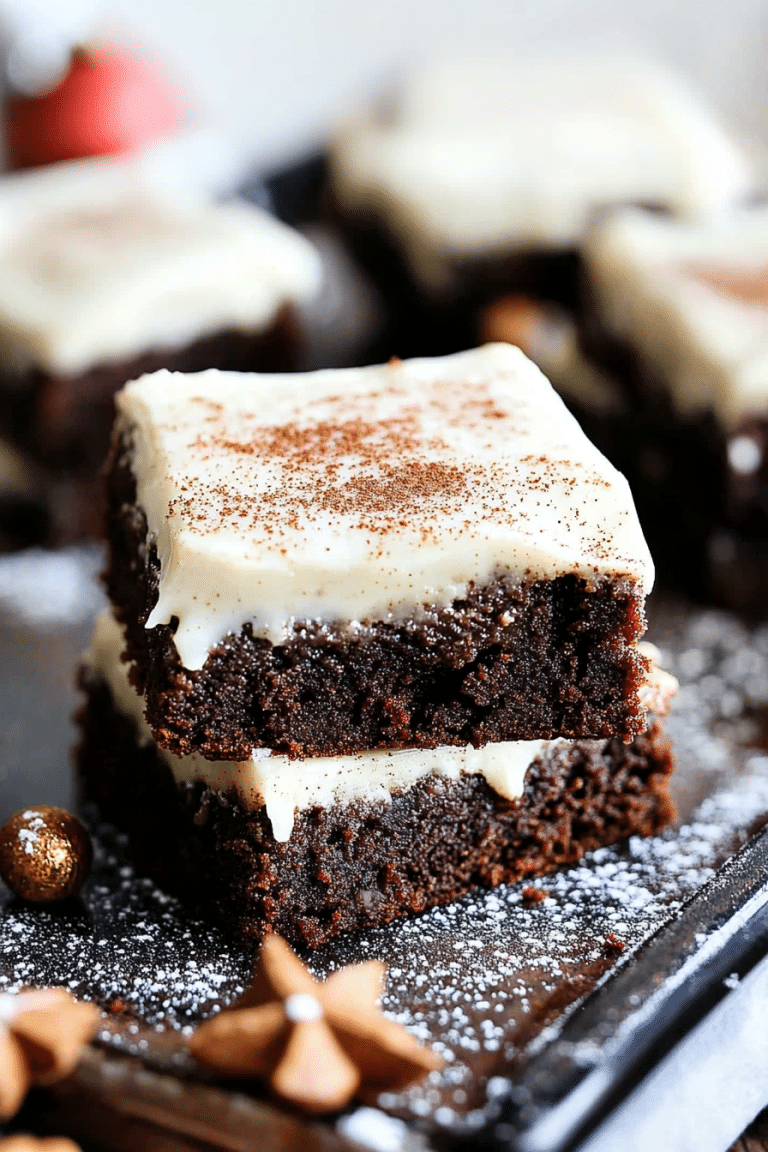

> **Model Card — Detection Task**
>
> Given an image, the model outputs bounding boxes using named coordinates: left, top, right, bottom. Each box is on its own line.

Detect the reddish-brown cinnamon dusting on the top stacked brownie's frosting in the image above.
left=169, top=373, right=610, bottom=555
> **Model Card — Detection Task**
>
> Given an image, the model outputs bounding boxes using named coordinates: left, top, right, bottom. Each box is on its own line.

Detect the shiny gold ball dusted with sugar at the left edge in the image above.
left=0, top=804, right=93, bottom=904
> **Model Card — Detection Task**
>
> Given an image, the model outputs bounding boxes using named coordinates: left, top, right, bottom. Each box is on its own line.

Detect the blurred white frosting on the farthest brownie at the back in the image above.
left=330, top=56, right=754, bottom=294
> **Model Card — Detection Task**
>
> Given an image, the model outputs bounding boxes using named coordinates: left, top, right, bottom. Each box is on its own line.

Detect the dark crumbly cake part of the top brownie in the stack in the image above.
left=105, top=444, right=646, bottom=760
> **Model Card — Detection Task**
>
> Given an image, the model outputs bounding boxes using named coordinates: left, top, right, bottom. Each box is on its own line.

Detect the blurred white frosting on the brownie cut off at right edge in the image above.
left=584, top=206, right=768, bottom=429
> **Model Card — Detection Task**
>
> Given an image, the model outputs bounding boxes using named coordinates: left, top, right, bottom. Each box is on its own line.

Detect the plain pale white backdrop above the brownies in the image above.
left=107, top=0, right=768, bottom=175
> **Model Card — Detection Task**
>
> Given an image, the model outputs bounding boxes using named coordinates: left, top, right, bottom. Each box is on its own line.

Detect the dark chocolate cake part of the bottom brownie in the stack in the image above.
left=77, top=673, right=674, bottom=947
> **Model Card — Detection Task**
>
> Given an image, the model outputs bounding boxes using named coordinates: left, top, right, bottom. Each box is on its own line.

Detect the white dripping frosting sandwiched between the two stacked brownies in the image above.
left=86, top=609, right=559, bottom=841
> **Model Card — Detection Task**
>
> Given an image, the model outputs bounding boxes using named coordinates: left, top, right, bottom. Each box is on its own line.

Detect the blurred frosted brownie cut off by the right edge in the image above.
left=579, top=206, right=768, bottom=615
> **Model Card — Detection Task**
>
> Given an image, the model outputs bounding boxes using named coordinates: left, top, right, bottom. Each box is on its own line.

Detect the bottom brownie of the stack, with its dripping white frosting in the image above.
left=77, top=612, right=675, bottom=947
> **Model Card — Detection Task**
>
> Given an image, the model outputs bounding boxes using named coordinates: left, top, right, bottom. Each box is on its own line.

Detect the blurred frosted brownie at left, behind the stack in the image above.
left=0, top=154, right=320, bottom=535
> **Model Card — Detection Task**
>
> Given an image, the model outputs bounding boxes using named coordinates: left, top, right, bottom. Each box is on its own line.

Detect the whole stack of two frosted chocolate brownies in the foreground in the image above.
left=78, top=344, right=672, bottom=946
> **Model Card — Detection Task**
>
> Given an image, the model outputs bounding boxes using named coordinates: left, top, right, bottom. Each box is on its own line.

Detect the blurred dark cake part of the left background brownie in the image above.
left=0, top=305, right=298, bottom=473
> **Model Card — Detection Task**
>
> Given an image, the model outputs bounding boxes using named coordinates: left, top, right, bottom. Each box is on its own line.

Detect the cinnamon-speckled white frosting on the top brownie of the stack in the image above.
left=117, top=344, right=653, bottom=669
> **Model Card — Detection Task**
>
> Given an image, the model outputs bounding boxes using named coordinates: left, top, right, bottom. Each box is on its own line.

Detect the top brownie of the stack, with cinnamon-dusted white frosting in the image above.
left=100, top=344, right=653, bottom=760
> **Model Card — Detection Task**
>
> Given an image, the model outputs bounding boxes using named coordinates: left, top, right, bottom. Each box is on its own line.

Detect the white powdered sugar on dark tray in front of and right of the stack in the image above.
left=0, top=605, right=768, bottom=1133
